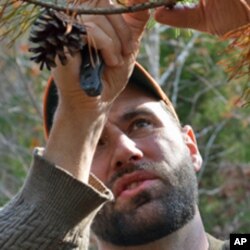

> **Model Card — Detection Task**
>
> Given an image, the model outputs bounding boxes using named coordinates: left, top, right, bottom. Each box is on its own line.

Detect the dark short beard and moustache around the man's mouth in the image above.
left=92, top=150, right=197, bottom=246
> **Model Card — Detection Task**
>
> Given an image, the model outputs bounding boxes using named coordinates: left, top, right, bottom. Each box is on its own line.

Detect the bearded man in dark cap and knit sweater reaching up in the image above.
left=0, top=0, right=248, bottom=250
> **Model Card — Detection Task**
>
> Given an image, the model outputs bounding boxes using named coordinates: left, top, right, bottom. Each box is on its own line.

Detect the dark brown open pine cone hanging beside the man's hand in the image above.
left=29, top=9, right=86, bottom=70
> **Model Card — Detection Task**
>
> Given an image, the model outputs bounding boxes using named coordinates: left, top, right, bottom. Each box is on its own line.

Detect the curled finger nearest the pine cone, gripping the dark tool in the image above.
left=84, top=22, right=123, bottom=66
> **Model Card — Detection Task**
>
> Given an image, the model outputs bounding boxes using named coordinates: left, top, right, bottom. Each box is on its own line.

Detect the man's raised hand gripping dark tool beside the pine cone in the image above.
left=53, top=0, right=149, bottom=106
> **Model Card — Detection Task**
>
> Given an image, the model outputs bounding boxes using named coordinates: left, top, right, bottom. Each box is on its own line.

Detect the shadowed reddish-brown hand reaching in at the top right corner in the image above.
left=155, top=0, right=250, bottom=36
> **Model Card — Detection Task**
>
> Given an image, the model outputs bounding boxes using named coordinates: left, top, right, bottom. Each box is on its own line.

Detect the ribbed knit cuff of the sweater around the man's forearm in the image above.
left=20, top=147, right=112, bottom=228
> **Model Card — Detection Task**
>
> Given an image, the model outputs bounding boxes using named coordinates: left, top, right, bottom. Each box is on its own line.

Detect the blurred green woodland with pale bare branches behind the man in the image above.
left=0, top=25, right=250, bottom=238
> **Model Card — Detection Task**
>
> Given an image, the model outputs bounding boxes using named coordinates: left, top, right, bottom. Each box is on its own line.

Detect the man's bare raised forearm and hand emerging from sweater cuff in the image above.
left=44, top=0, right=148, bottom=182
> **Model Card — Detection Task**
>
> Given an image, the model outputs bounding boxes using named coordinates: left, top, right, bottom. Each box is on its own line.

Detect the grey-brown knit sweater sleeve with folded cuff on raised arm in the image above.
left=0, top=147, right=112, bottom=250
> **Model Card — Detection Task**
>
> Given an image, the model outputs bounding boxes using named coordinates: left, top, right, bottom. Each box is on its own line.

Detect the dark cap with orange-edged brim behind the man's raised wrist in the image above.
left=43, top=63, right=179, bottom=137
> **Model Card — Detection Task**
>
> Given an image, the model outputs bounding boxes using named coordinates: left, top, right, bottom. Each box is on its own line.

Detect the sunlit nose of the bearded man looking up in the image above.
left=111, top=134, right=143, bottom=168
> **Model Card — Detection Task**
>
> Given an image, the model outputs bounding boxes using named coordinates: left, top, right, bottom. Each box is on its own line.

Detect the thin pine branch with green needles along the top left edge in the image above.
left=0, top=0, right=181, bottom=46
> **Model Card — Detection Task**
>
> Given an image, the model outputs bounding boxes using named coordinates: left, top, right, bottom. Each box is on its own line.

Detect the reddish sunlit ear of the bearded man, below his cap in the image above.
left=182, top=125, right=202, bottom=172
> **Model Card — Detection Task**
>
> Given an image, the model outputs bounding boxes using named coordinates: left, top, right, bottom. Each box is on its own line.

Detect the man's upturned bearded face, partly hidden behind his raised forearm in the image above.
left=92, top=87, right=197, bottom=246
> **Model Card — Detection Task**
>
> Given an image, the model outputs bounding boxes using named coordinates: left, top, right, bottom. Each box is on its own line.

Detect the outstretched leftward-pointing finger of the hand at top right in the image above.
left=154, top=5, right=207, bottom=31
